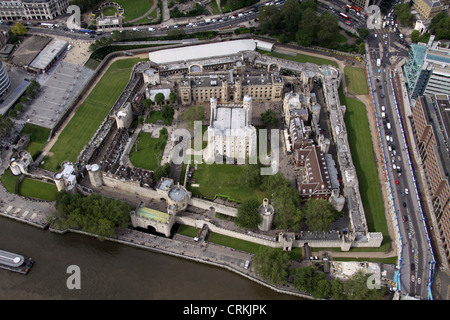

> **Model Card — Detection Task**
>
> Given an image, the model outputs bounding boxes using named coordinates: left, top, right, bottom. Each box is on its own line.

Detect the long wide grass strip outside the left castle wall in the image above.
left=43, top=58, right=141, bottom=171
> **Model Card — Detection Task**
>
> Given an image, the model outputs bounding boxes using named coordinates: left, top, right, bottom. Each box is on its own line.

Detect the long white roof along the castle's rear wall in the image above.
left=148, top=39, right=256, bottom=64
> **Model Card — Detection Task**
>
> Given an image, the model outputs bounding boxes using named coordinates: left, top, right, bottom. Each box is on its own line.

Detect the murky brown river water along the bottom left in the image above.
left=0, top=217, right=299, bottom=300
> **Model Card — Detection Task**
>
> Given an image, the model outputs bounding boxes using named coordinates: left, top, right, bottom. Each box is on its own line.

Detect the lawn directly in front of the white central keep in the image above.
left=187, top=163, right=267, bottom=202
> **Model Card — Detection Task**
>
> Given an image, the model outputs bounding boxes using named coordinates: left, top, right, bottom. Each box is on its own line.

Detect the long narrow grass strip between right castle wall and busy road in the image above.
left=339, top=87, right=389, bottom=250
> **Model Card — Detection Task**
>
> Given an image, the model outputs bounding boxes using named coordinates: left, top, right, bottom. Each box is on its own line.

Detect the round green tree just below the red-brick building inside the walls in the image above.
left=302, top=199, right=339, bottom=231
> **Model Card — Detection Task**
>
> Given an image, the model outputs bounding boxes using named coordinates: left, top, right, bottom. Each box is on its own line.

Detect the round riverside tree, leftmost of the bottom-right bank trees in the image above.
left=253, top=247, right=291, bottom=284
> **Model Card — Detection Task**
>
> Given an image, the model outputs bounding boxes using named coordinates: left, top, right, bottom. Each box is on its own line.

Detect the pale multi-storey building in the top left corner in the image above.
left=0, top=0, right=69, bottom=21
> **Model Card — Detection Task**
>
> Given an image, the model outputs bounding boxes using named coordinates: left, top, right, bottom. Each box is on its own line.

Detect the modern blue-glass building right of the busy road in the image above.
left=403, top=43, right=450, bottom=99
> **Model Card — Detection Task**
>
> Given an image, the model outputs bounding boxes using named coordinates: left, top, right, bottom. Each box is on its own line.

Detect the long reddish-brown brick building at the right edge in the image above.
left=412, top=95, right=450, bottom=262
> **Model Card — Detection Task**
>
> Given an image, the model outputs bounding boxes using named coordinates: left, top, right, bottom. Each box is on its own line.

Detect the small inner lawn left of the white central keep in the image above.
left=130, top=132, right=167, bottom=170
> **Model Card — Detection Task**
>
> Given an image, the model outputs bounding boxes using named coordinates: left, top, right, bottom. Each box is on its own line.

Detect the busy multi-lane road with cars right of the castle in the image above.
left=367, top=26, right=433, bottom=299
